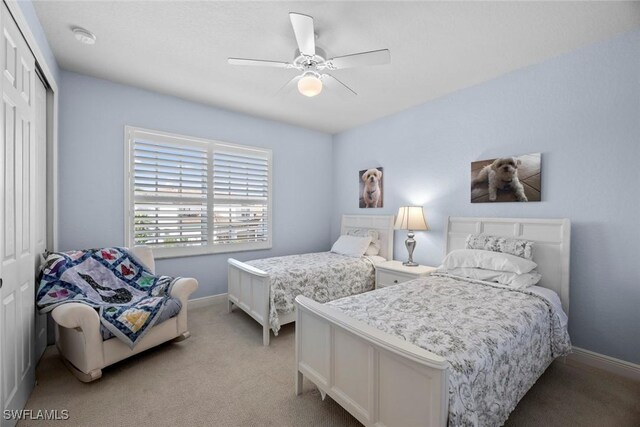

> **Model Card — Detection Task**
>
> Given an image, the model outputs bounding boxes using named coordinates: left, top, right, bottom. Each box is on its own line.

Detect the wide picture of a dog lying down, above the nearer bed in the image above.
left=471, top=153, right=542, bottom=203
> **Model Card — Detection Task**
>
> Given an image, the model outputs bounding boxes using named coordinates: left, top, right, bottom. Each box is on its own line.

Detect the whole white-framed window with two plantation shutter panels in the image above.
left=125, top=126, right=272, bottom=258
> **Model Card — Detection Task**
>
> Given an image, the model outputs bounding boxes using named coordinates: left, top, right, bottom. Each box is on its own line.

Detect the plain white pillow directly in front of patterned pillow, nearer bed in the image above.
left=442, top=249, right=538, bottom=274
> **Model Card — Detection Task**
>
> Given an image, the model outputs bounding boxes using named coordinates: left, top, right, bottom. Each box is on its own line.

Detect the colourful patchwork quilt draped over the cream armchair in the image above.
left=36, top=248, right=180, bottom=348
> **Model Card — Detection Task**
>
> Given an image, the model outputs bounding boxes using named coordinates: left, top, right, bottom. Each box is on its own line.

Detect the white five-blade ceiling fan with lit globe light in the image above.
left=228, top=12, right=391, bottom=96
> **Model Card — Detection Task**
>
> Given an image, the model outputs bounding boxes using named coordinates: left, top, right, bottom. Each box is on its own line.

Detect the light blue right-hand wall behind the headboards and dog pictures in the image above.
left=332, top=31, right=640, bottom=363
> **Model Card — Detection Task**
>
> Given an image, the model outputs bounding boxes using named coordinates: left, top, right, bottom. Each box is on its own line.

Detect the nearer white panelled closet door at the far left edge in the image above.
left=0, top=3, right=36, bottom=425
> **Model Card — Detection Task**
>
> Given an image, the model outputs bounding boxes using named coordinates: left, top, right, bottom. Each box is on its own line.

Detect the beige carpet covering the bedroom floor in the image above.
left=19, top=304, right=640, bottom=427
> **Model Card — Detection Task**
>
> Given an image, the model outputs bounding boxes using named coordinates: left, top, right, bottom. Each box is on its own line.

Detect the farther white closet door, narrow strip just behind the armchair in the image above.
left=34, top=77, right=47, bottom=363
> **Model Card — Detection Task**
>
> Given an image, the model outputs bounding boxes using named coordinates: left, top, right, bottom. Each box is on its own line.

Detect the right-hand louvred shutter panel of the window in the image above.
left=213, top=146, right=271, bottom=245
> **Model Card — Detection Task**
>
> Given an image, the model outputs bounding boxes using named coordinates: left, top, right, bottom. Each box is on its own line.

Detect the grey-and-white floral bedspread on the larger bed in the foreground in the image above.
left=328, top=275, right=571, bottom=426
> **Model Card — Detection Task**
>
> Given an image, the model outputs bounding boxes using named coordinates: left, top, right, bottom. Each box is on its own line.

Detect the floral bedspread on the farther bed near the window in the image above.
left=247, top=252, right=375, bottom=335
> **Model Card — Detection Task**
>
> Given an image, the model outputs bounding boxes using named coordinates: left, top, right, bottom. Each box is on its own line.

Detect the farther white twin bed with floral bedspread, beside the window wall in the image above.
left=228, top=215, right=394, bottom=346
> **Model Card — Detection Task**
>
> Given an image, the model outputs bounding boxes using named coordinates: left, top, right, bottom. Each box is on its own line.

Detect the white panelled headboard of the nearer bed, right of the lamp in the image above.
left=445, top=217, right=571, bottom=314
